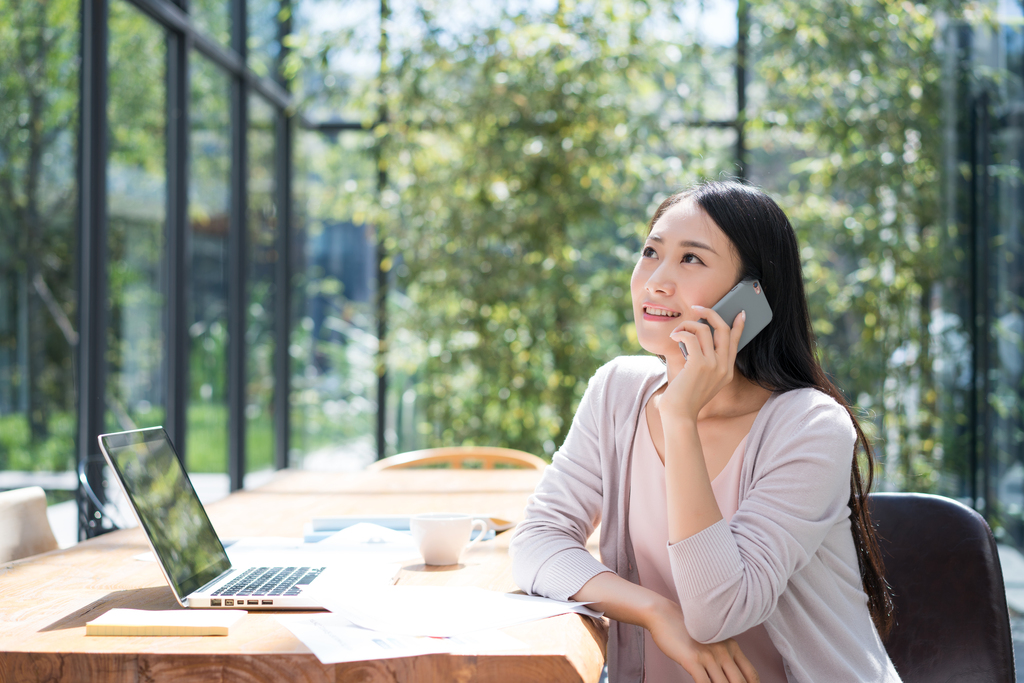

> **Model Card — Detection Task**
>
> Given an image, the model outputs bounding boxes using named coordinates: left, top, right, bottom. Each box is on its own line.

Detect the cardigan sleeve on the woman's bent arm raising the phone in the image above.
left=669, top=399, right=856, bottom=643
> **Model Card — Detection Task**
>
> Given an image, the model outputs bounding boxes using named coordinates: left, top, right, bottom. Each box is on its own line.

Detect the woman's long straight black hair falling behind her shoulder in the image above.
left=648, top=181, right=893, bottom=638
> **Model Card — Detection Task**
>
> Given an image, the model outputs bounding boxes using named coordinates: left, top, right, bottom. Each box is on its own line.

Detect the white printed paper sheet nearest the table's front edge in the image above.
left=276, top=614, right=526, bottom=664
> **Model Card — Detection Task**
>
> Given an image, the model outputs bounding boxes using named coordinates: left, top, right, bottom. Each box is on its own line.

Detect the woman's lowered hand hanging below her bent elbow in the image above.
left=644, top=600, right=761, bottom=683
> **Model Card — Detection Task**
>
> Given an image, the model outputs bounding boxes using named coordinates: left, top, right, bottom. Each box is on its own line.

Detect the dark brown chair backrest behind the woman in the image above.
left=868, top=494, right=1015, bottom=683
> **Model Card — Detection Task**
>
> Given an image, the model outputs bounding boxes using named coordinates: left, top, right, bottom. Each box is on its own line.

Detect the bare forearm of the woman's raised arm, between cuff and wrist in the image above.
left=664, top=420, right=722, bottom=544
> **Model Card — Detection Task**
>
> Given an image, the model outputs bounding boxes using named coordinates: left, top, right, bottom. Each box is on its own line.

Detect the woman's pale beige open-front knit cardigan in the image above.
left=510, top=356, right=899, bottom=683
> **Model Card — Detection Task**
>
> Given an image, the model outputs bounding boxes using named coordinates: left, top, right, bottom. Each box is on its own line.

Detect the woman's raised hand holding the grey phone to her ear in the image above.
left=660, top=306, right=746, bottom=420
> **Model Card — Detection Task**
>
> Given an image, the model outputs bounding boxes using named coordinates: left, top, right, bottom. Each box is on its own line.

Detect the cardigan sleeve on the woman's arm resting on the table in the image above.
left=509, top=362, right=610, bottom=600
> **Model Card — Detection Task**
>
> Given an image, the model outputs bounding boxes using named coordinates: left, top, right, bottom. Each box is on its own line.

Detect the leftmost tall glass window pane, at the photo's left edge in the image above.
left=0, top=1, right=79, bottom=491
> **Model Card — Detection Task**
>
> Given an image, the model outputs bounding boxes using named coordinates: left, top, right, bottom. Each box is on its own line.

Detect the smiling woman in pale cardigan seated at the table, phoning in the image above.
left=511, top=182, right=899, bottom=683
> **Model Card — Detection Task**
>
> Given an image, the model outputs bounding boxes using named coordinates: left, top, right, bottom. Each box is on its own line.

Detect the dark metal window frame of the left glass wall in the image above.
left=75, top=0, right=295, bottom=539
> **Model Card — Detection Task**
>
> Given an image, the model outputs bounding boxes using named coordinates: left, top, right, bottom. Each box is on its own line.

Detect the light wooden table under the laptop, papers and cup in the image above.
left=0, top=470, right=607, bottom=683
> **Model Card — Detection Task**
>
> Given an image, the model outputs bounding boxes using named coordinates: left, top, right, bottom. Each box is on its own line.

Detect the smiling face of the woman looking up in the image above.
left=630, top=200, right=741, bottom=360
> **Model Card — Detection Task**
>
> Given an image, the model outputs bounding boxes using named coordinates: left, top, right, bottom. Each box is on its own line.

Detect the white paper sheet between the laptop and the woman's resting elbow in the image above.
left=310, top=586, right=601, bottom=637
